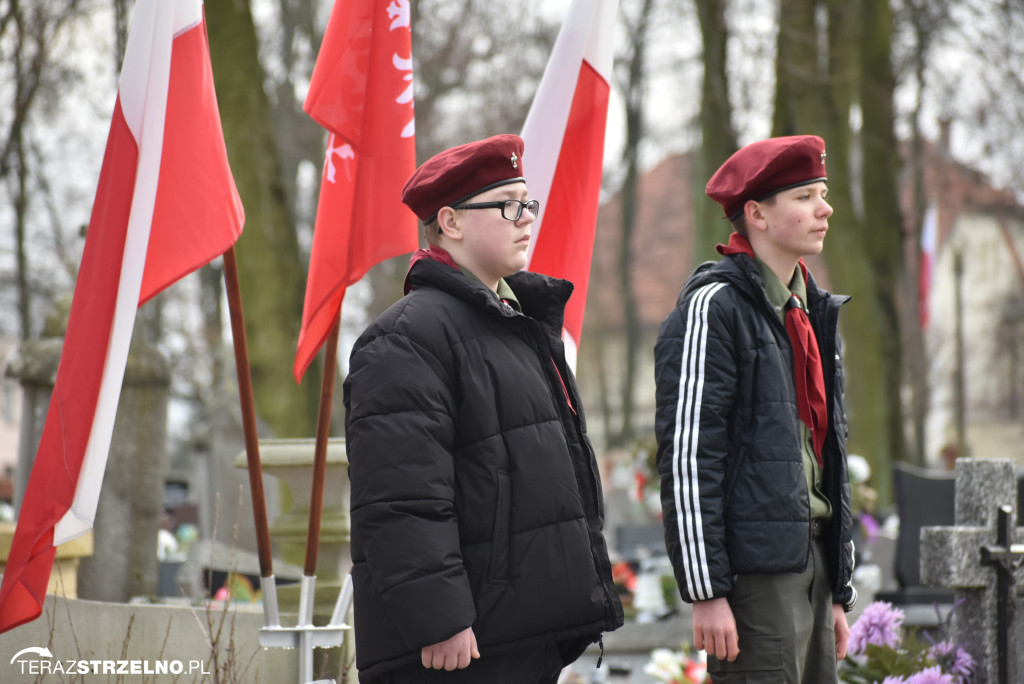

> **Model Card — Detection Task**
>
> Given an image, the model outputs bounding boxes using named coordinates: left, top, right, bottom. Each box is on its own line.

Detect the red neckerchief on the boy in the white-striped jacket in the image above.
left=715, top=232, right=828, bottom=466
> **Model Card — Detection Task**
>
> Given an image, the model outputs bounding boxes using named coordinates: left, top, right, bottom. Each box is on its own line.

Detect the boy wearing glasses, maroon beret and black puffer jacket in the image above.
left=344, top=135, right=623, bottom=684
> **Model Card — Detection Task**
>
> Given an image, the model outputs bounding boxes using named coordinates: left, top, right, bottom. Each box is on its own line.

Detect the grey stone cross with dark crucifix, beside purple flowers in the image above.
left=921, top=458, right=1024, bottom=684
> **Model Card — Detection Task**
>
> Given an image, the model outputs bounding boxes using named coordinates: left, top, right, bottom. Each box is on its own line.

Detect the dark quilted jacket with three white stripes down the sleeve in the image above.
left=654, top=250, right=856, bottom=609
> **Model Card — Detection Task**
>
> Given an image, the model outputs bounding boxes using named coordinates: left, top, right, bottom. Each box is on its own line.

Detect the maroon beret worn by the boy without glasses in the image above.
left=705, top=135, right=828, bottom=220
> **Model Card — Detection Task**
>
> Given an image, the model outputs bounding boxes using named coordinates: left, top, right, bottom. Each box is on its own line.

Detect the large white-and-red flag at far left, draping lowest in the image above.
left=0, top=0, right=245, bottom=632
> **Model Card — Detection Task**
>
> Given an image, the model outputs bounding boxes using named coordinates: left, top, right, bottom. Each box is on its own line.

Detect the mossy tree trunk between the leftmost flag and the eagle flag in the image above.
left=206, top=0, right=319, bottom=437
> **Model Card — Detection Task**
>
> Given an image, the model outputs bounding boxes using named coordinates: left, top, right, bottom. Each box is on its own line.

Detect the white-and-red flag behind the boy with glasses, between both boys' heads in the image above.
left=522, top=0, right=618, bottom=368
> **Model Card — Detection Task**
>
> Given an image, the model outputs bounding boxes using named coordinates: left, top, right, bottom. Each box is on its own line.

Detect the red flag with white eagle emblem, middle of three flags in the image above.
left=293, top=0, right=418, bottom=382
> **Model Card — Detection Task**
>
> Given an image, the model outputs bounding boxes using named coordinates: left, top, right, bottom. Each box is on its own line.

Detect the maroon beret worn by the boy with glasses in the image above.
left=401, top=135, right=525, bottom=223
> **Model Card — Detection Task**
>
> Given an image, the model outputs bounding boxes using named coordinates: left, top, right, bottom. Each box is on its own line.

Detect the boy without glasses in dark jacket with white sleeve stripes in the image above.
left=654, top=135, right=857, bottom=684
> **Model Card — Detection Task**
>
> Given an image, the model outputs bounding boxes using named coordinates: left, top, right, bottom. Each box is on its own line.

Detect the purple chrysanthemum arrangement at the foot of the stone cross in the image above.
left=840, top=601, right=975, bottom=684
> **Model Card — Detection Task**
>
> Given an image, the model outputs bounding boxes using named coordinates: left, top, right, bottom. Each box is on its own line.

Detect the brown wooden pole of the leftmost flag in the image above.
left=224, top=245, right=273, bottom=577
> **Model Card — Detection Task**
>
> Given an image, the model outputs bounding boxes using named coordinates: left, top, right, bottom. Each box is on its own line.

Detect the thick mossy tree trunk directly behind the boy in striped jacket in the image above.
left=773, top=0, right=902, bottom=504
